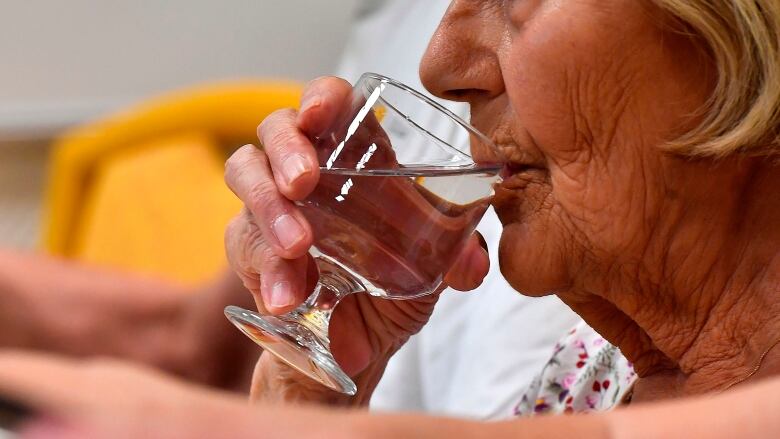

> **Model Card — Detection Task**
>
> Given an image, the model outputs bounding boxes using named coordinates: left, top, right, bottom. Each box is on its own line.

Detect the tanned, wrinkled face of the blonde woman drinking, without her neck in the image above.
left=421, top=0, right=712, bottom=295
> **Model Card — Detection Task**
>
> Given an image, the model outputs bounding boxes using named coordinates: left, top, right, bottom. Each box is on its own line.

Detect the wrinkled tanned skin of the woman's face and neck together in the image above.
left=420, top=0, right=780, bottom=397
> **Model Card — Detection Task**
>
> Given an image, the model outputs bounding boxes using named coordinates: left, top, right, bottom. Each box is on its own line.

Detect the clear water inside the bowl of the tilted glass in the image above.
left=299, top=166, right=499, bottom=299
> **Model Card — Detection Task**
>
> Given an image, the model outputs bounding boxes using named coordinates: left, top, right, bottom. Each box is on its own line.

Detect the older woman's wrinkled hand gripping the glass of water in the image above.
left=225, top=78, right=489, bottom=403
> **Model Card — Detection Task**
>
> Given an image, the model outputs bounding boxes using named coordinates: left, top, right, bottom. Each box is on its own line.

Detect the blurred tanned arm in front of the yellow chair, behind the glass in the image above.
left=0, top=250, right=258, bottom=388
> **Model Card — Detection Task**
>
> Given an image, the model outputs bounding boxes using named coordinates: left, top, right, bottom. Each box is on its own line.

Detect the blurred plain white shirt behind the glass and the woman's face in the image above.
left=339, top=0, right=579, bottom=419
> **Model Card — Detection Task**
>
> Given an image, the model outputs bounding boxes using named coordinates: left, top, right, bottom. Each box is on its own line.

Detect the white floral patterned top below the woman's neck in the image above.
left=514, top=322, right=637, bottom=416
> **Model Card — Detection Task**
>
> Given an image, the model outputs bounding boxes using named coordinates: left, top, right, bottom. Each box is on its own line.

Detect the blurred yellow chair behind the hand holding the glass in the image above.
left=43, top=81, right=301, bottom=284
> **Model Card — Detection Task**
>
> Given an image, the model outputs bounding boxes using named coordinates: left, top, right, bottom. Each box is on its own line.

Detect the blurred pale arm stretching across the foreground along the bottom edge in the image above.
left=0, top=352, right=780, bottom=439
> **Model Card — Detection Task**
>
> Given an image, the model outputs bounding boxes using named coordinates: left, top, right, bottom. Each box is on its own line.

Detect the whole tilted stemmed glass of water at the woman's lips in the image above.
left=225, top=73, right=502, bottom=395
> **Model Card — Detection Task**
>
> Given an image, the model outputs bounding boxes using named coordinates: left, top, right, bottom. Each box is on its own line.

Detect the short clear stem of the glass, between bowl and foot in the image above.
left=286, top=255, right=365, bottom=349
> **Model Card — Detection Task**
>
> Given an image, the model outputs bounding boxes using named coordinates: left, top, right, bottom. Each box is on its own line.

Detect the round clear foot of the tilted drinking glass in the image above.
left=225, top=306, right=357, bottom=395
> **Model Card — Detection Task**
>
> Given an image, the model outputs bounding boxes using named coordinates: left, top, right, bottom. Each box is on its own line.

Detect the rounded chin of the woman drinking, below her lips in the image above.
left=498, top=222, right=569, bottom=297
